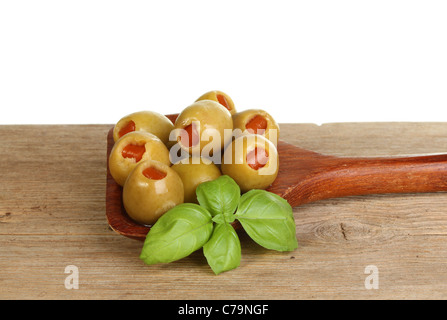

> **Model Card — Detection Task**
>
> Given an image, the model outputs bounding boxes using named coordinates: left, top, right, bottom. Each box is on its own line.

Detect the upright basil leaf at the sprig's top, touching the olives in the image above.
left=196, top=175, right=241, bottom=216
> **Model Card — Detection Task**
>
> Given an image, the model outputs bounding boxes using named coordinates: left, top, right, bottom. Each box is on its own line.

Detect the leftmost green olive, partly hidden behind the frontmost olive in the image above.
left=109, top=131, right=171, bottom=186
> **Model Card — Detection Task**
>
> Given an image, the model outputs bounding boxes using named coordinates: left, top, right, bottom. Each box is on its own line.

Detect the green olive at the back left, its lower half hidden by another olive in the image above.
left=113, top=111, right=174, bottom=144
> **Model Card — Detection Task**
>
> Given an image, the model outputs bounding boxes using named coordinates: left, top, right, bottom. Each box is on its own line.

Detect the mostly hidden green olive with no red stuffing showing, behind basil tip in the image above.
left=171, top=157, right=221, bottom=203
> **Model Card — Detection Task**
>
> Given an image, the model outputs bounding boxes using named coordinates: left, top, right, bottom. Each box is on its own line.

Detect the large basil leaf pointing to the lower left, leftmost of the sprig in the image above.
left=140, top=203, right=213, bottom=264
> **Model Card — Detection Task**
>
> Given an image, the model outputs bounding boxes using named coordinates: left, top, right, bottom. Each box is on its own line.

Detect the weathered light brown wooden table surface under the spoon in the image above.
left=0, top=123, right=447, bottom=299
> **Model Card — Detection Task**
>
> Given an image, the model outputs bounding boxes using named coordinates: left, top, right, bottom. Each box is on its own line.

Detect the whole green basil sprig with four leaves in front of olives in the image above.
left=140, top=175, right=298, bottom=274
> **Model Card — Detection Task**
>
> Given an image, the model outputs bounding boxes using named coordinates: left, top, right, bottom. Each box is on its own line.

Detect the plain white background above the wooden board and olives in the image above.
left=0, top=0, right=447, bottom=124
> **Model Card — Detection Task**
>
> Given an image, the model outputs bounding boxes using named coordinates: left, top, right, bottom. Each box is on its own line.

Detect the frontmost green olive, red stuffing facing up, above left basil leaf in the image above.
left=123, top=160, right=184, bottom=225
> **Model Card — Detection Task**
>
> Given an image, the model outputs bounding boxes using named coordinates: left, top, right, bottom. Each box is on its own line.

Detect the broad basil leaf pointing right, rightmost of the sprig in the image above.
left=235, top=190, right=298, bottom=251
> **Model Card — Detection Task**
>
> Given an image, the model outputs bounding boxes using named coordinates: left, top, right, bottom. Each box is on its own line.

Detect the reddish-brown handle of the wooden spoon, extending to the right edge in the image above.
left=284, top=154, right=447, bottom=205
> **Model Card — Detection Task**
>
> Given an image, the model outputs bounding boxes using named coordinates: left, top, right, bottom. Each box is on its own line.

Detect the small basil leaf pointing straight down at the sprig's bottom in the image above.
left=203, top=223, right=241, bottom=274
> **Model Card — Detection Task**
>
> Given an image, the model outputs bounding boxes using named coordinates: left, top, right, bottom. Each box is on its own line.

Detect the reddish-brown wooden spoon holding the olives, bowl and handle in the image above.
left=106, top=114, right=447, bottom=240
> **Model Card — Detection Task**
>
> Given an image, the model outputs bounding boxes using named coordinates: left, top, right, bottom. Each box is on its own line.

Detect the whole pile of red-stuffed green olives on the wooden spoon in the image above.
left=109, top=90, right=279, bottom=225
